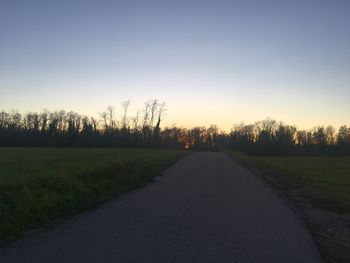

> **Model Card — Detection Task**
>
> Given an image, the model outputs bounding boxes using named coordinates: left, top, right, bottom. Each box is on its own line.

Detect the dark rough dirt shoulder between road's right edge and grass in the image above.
left=226, top=152, right=350, bottom=263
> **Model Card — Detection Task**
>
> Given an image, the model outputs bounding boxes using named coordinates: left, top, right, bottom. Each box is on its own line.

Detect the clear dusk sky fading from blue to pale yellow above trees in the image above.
left=0, top=0, right=350, bottom=130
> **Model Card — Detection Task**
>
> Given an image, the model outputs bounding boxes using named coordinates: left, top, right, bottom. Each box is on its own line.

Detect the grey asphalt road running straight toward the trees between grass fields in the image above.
left=0, top=152, right=321, bottom=263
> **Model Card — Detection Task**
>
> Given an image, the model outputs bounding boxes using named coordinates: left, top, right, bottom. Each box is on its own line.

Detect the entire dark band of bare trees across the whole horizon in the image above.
left=0, top=103, right=350, bottom=154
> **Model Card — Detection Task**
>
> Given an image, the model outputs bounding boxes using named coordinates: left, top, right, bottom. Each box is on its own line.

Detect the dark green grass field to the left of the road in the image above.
left=0, top=148, right=186, bottom=241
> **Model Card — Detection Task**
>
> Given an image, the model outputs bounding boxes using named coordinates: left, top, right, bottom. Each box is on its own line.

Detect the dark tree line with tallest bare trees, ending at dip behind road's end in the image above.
left=0, top=100, right=218, bottom=150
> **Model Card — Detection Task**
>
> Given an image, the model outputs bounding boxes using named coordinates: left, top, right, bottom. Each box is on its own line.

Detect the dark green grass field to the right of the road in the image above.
left=228, top=152, right=350, bottom=215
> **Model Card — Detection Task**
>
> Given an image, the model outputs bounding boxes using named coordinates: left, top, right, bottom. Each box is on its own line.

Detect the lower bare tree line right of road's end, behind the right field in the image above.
left=229, top=119, right=350, bottom=155
